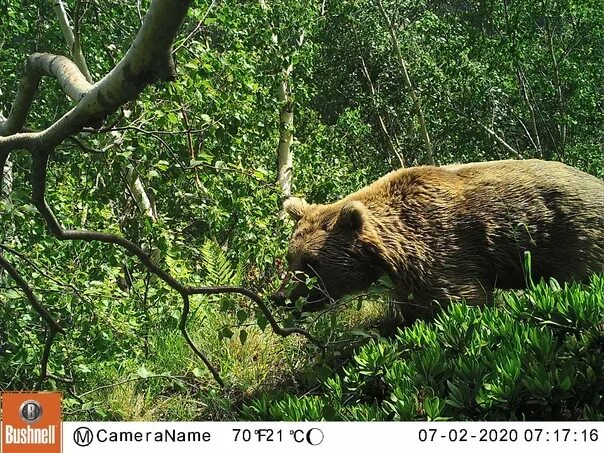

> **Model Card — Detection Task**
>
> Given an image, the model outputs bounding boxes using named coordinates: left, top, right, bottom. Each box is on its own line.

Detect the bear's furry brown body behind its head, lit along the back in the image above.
left=358, top=159, right=604, bottom=288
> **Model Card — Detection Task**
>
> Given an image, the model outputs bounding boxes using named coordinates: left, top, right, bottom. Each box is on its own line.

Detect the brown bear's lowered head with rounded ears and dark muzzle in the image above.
left=273, top=197, right=383, bottom=311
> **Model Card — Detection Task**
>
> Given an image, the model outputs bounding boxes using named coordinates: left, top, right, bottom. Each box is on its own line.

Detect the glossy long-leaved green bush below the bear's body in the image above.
left=242, top=276, right=604, bottom=420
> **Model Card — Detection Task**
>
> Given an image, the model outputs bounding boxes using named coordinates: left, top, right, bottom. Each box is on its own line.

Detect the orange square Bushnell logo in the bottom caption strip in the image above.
left=1, top=392, right=62, bottom=453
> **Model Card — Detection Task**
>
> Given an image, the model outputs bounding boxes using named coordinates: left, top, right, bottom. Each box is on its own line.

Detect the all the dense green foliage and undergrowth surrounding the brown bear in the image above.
left=0, top=0, right=604, bottom=420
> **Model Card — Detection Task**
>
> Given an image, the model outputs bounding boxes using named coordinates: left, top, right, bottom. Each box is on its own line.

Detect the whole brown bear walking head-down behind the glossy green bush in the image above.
left=273, top=160, right=604, bottom=323
